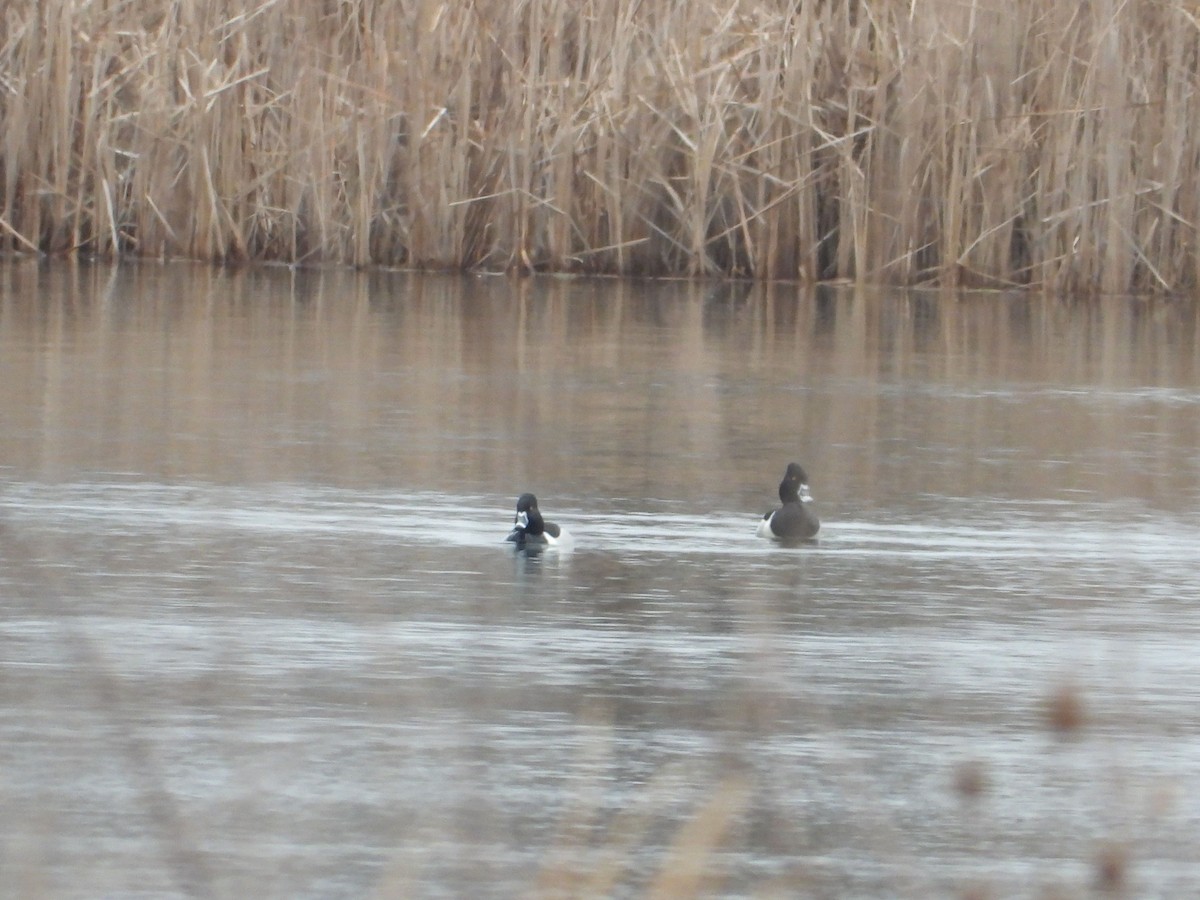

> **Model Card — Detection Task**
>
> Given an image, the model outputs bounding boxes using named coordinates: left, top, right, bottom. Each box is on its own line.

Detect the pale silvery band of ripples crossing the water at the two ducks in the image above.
left=0, top=482, right=1200, bottom=564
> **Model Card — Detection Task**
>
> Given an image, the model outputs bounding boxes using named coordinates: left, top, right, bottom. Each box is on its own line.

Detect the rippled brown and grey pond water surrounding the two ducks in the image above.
left=0, top=264, right=1200, bottom=898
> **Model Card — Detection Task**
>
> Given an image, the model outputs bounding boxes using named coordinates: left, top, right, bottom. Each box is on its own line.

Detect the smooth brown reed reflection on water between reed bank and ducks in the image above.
left=0, top=265, right=1200, bottom=509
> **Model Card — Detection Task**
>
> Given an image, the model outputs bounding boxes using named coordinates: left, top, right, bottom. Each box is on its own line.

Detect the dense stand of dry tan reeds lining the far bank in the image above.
left=0, top=0, right=1200, bottom=293
